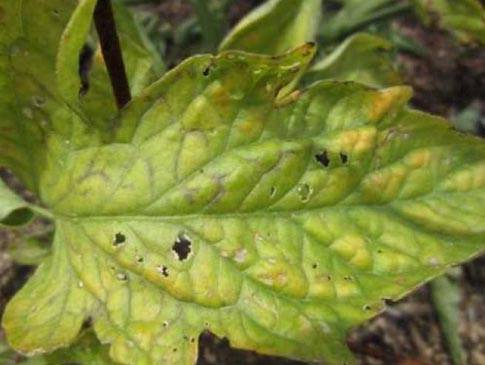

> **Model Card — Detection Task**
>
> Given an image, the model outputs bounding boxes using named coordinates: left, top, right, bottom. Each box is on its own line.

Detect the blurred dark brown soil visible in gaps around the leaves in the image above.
left=0, top=0, right=485, bottom=365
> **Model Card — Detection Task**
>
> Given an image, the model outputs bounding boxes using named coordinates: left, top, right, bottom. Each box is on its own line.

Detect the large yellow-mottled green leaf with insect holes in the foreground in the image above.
left=0, top=0, right=485, bottom=365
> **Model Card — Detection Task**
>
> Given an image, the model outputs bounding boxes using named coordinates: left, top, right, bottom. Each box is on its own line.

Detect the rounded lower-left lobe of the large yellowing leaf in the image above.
left=2, top=232, right=95, bottom=356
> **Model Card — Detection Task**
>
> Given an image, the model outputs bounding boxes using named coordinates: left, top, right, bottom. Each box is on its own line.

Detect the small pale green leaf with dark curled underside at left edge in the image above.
left=0, top=179, right=33, bottom=226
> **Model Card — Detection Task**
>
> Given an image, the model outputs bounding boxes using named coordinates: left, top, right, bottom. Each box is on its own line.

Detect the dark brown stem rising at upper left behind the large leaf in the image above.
left=94, top=0, right=131, bottom=109
